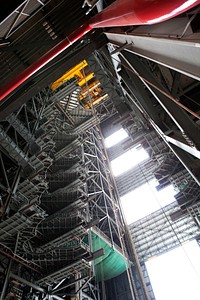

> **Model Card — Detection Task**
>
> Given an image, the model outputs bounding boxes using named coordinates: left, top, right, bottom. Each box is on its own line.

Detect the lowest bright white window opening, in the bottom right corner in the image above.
left=145, top=240, right=200, bottom=300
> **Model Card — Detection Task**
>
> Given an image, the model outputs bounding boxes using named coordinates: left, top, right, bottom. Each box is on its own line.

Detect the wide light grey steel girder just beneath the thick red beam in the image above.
left=106, top=30, right=200, bottom=80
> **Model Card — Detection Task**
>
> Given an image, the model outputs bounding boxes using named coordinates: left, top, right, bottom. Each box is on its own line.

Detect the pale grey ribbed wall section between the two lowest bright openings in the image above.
left=130, top=202, right=199, bottom=262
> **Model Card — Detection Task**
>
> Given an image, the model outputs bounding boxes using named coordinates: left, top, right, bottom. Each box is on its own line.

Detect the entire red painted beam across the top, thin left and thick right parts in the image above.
left=0, top=0, right=200, bottom=101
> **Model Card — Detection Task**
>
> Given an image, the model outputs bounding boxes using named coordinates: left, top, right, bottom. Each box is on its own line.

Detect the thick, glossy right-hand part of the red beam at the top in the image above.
left=90, top=0, right=200, bottom=28
